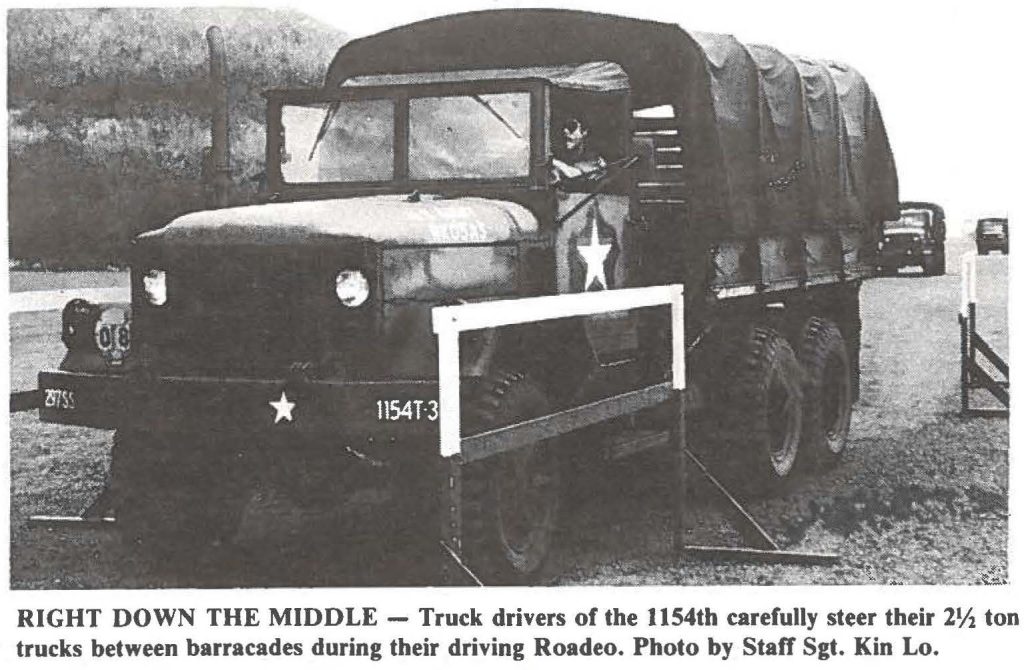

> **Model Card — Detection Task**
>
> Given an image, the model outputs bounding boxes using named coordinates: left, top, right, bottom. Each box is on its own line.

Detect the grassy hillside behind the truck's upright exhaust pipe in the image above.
left=7, top=8, right=345, bottom=268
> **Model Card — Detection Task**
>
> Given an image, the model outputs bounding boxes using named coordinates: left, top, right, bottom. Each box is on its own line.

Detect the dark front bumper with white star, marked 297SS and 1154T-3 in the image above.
left=39, top=371, right=437, bottom=444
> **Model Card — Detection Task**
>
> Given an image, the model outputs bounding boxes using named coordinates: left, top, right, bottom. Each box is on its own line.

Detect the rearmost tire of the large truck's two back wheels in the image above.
left=798, top=317, right=853, bottom=467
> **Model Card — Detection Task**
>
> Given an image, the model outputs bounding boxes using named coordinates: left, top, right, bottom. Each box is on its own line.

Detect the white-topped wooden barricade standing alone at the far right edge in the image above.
left=957, top=252, right=1010, bottom=417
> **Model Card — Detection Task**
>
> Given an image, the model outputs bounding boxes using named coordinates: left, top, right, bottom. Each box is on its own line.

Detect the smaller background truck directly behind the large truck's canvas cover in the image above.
left=879, top=202, right=946, bottom=277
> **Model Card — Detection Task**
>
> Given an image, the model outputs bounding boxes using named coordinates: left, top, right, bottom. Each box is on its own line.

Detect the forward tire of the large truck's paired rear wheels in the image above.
left=722, top=326, right=804, bottom=494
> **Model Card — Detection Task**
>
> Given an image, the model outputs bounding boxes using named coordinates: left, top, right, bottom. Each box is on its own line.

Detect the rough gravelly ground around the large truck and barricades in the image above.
left=10, top=248, right=1009, bottom=588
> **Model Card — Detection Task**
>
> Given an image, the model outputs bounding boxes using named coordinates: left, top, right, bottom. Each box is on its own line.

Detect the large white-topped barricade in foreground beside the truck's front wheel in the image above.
left=432, top=284, right=687, bottom=584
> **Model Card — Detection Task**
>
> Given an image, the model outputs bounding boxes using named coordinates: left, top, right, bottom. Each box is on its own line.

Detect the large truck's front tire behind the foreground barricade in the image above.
left=462, top=374, right=561, bottom=584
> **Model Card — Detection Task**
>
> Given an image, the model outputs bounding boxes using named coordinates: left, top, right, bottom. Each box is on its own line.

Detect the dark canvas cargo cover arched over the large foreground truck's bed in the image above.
left=325, top=9, right=898, bottom=241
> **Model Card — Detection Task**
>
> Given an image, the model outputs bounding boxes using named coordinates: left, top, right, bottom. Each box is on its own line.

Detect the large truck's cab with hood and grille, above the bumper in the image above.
left=125, top=64, right=636, bottom=389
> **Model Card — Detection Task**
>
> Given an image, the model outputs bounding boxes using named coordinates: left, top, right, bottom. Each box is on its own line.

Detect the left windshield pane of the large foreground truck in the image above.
left=281, top=99, right=394, bottom=183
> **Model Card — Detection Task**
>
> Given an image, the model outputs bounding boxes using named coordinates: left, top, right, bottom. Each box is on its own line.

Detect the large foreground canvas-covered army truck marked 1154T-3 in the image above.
left=28, top=10, right=898, bottom=582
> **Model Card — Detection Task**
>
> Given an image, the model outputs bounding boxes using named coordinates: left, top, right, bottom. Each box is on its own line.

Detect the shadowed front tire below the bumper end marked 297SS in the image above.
left=111, top=429, right=252, bottom=558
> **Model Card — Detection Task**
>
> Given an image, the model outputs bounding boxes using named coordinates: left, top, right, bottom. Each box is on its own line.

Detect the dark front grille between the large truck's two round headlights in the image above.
left=135, top=249, right=375, bottom=377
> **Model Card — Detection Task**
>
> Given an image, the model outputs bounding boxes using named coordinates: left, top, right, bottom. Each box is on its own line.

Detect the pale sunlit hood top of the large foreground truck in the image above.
left=138, top=195, right=538, bottom=246
